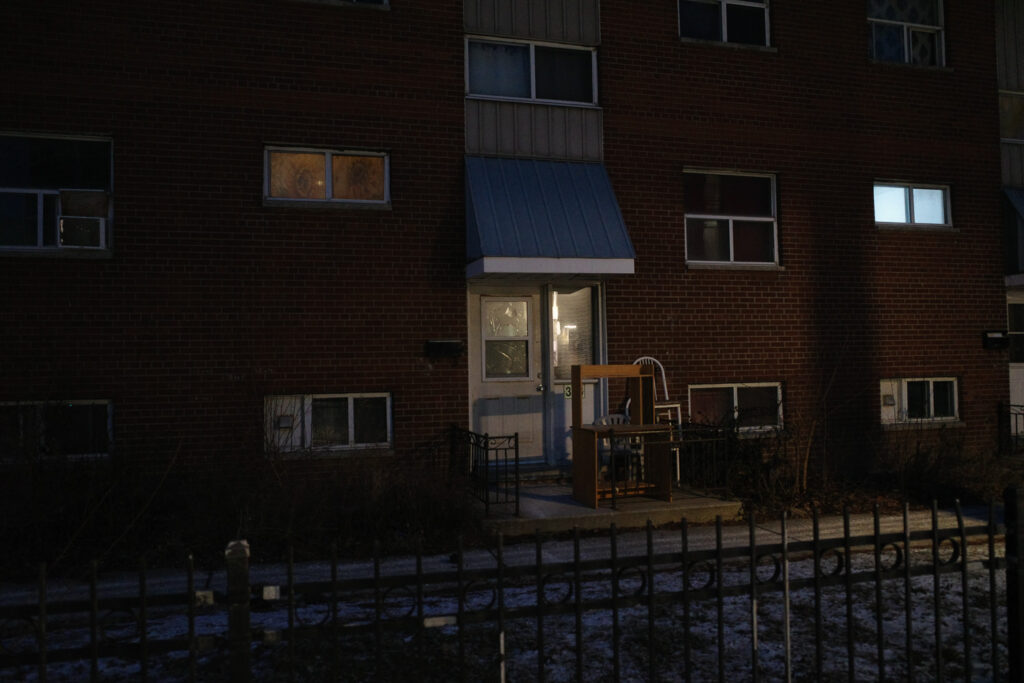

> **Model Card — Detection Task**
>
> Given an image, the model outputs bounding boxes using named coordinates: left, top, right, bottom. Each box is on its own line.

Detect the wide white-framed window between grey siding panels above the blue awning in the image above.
left=466, top=40, right=597, bottom=104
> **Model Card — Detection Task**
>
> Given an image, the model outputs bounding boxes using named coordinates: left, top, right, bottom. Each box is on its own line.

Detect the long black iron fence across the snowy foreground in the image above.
left=0, top=492, right=1024, bottom=681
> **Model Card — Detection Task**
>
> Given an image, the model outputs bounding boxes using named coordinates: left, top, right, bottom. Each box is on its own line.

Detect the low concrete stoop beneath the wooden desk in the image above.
left=483, top=482, right=742, bottom=538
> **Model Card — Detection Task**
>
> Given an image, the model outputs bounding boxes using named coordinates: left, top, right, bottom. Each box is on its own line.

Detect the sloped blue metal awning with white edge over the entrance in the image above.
left=466, top=157, right=636, bottom=278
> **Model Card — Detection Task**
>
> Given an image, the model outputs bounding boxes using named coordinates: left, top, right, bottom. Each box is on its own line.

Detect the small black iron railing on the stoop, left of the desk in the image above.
left=451, top=426, right=520, bottom=515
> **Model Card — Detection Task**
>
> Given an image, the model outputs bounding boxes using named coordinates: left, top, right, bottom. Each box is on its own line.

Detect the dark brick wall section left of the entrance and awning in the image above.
left=0, top=0, right=466, bottom=471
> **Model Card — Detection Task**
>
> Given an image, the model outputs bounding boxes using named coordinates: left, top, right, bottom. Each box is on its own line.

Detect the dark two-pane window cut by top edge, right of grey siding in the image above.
left=679, top=0, right=769, bottom=45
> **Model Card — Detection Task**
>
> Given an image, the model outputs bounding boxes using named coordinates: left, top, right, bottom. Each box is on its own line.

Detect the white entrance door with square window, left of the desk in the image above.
left=469, top=288, right=544, bottom=460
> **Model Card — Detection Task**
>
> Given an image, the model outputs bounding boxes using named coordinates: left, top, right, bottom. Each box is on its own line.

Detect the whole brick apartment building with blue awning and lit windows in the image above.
left=0, top=0, right=1003, bottom=481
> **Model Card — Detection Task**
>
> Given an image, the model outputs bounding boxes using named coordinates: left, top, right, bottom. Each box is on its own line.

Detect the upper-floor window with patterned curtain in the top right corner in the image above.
left=867, top=0, right=945, bottom=67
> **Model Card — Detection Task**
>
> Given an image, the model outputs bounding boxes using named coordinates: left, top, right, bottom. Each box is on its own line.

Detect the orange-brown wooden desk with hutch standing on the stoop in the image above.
left=571, top=365, right=672, bottom=508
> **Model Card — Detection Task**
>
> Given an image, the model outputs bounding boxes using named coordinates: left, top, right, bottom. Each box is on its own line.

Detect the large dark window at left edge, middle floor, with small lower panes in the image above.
left=0, top=135, right=112, bottom=251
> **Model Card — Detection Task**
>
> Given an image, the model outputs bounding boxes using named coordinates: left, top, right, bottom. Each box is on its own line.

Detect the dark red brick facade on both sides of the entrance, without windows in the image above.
left=0, top=0, right=1008, bottom=475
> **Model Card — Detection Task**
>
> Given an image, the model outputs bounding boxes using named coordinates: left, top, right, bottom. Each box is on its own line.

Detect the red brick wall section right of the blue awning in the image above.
left=600, top=2, right=1007, bottom=466
